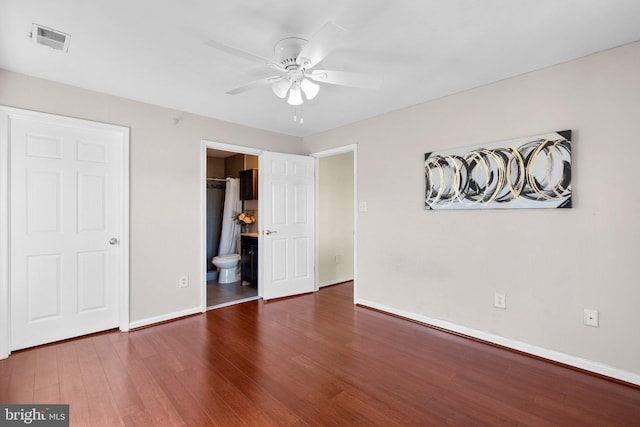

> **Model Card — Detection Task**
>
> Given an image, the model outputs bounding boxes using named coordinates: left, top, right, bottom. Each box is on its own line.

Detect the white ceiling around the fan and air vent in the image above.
left=0, top=0, right=640, bottom=136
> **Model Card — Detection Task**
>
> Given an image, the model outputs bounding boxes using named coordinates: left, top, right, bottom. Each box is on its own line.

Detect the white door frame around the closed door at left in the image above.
left=0, top=106, right=129, bottom=359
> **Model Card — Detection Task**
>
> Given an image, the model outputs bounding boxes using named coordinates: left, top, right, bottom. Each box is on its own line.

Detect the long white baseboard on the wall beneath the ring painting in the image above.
left=355, top=298, right=640, bottom=385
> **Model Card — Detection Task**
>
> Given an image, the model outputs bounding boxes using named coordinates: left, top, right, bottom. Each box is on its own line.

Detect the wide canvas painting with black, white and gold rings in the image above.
left=424, top=130, right=571, bottom=210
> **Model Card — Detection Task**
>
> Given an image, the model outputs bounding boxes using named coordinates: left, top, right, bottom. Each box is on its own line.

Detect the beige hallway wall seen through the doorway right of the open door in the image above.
left=318, top=152, right=354, bottom=286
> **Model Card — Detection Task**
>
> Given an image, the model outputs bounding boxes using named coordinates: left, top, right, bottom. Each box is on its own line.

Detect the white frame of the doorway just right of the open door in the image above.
left=310, top=144, right=358, bottom=301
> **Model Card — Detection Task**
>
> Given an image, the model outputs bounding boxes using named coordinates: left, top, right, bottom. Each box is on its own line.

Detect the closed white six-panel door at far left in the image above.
left=9, top=115, right=123, bottom=350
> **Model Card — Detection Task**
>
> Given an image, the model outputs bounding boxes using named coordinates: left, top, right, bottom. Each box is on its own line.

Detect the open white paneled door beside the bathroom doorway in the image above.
left=260, top=152, right=315, bottom=300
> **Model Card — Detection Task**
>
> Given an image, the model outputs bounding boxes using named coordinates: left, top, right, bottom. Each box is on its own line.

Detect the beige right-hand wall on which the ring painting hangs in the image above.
left=305, top=43, right=640, bottom=381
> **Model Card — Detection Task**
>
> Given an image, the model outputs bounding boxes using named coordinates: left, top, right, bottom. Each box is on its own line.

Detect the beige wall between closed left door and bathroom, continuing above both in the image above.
left=0, top=70, right=301, bottom=322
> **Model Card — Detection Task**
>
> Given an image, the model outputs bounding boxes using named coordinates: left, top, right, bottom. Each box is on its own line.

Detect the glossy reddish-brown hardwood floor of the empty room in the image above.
left=0, top=283, right=640, bottom=426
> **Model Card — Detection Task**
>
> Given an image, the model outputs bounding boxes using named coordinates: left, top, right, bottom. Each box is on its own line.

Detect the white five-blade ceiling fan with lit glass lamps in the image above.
left=206, top=22, right=382, bottom=106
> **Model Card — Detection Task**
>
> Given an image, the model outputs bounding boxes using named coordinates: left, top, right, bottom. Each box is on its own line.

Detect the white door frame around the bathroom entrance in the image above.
left=200, top=139, right=264, bottom=313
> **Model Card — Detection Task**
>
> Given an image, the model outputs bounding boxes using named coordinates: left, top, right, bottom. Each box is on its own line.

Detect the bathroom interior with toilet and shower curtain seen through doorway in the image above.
left=204, top=147, right=258, bottom=310
